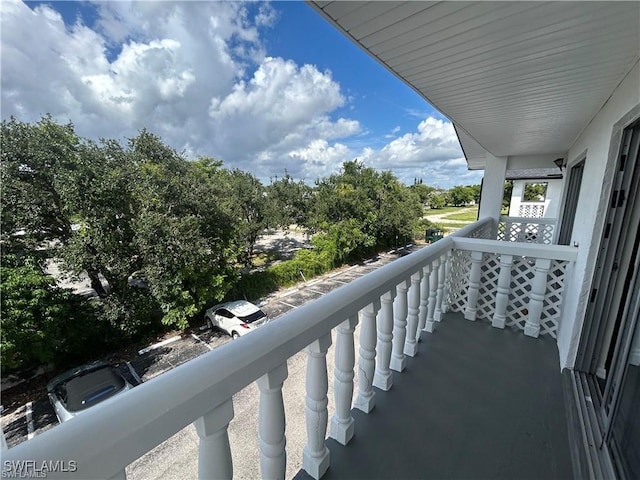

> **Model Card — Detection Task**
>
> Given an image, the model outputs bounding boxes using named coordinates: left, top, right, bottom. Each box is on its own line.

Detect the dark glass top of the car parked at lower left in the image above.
left=56, top=367, right=125, bottom=411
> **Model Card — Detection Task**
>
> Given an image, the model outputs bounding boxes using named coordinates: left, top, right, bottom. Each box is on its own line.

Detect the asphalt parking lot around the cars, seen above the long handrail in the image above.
left=2, top=246, right=418, bottom=472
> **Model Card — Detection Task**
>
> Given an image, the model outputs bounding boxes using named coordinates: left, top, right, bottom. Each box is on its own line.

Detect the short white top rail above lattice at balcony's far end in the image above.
left=454, top=237, right=578, bottom=262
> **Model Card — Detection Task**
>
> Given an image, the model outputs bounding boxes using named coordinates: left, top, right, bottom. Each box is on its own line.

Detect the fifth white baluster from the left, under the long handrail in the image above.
left=353, top=300, right=380, bottom=413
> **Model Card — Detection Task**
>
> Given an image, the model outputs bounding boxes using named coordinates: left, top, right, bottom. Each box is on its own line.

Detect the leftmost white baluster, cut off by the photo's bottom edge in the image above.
left=193, top=399, right=238, bottom=479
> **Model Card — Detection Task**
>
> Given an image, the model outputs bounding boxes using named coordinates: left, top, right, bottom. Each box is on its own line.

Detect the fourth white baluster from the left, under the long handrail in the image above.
left=331, top=315, right=358, bottom=445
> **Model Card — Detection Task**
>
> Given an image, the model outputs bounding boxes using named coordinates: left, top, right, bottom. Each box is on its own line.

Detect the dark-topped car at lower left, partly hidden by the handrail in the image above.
left=47, top=361, right=132, bottom=423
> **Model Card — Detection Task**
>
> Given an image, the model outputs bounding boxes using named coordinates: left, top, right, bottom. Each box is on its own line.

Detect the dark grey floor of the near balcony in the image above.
left=295, top=313, right=573, bottom=480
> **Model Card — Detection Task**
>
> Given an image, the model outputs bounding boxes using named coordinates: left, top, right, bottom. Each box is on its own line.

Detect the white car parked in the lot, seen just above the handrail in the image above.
left=204, top=300, right=269, bottom=338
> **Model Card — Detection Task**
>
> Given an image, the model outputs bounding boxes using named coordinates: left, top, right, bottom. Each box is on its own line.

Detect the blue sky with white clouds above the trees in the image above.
left=0, top=0, right=481, bottom=188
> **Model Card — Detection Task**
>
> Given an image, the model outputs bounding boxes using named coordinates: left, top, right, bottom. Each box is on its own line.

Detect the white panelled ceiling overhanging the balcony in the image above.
left=310, top=1, right=640, bottom=168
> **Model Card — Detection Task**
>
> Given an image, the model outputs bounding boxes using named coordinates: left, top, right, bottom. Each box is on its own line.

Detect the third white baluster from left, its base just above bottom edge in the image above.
left=302, top=333, right=331, bottom=480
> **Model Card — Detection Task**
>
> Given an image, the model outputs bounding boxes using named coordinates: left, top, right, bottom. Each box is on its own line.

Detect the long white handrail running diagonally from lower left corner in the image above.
left=3, top=218, right=492, bottom=478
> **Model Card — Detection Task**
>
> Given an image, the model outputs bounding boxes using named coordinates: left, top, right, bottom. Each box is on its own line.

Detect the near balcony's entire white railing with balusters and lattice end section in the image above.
left=3, top=219, right=576, bottom=479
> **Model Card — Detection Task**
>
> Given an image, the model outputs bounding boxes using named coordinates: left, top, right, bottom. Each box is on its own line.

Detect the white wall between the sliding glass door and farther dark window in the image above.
left=558, top=64, right=640, bottom=368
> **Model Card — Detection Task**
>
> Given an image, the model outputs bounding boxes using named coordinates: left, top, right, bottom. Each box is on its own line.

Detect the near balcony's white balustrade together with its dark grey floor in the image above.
left=3, top=219, right=577, bottom=478
